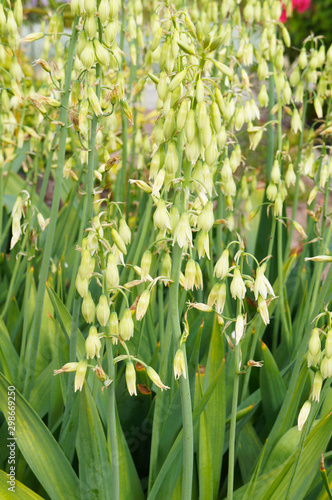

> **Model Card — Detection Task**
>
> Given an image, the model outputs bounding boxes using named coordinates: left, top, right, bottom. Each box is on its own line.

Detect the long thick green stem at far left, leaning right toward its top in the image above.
left=23, top=15, right=79, bottom=399
